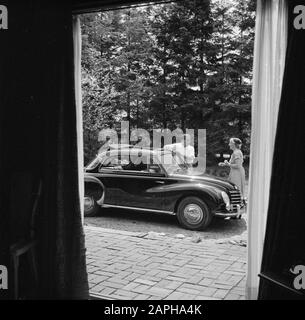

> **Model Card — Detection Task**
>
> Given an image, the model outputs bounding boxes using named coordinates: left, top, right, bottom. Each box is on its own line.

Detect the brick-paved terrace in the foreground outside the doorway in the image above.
left=85, top=226, right=246, bottom=300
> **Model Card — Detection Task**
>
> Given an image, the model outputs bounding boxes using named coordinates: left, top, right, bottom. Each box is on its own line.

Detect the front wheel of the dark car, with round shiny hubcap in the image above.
left=177, top=197, right=213, bottom=230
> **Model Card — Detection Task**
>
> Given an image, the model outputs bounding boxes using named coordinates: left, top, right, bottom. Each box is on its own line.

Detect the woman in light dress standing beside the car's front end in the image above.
left=219, top=138, right=246, bottom=199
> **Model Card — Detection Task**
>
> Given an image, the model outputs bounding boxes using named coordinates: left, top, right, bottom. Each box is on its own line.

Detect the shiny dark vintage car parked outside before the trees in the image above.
left=84, top=146, right=242, bottom=230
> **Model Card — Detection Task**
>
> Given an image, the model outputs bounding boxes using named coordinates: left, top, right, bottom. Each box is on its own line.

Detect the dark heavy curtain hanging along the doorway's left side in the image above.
left=41, top=1, right=88, bottom=298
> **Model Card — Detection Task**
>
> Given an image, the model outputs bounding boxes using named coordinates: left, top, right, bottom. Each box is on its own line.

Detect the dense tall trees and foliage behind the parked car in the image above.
left=82, top=0, right=255, bottom=162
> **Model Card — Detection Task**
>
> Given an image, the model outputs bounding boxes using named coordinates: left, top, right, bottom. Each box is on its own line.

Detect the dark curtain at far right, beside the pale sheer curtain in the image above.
left=259, top=0, right=305, bottom=299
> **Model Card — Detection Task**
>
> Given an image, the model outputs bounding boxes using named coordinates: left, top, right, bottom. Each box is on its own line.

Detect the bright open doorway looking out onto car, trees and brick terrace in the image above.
left=80, top=0, right=256, bottom=299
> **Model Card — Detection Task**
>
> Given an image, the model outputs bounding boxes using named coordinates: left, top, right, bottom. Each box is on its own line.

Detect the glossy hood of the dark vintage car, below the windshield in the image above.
left=171, top=173, right=236, bottom=191
